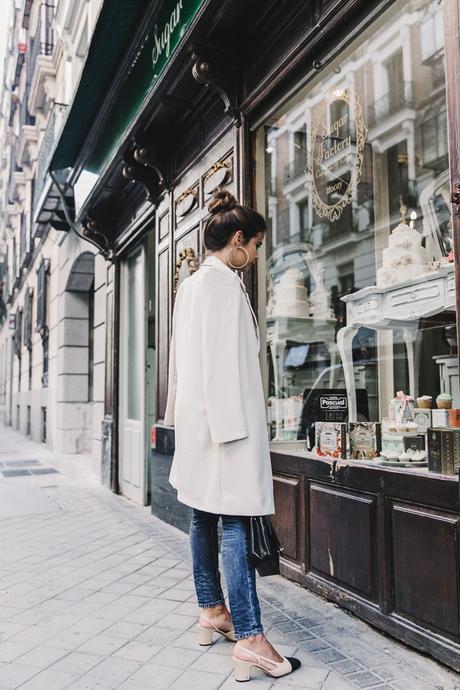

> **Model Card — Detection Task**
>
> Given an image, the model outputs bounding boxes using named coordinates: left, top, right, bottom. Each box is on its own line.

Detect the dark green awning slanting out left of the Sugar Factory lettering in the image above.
left=50, top=0, right=150, bottom=170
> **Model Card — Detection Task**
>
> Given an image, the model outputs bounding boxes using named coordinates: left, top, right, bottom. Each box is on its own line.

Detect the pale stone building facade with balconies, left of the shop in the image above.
left=0, top=0, right=111, bottom=470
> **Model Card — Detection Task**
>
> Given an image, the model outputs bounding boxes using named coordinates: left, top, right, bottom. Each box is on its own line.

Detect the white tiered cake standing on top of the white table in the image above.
left=377, top=222, right=430, bottom=287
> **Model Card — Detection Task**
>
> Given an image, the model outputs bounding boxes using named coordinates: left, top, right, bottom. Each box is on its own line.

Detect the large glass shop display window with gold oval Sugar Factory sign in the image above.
left=258, top=0, right=460, bottom=466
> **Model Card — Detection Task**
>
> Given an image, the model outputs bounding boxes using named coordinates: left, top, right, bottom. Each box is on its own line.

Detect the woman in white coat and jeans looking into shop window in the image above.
left=164, top=190, right=300, bottom=681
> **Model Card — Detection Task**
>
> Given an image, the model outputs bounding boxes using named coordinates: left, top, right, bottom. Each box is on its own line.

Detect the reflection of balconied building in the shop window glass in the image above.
left=266, top=0, right=452, bottom=438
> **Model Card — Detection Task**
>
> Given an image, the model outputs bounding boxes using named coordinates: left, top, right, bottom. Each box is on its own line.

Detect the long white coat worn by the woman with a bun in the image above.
left=164, top=256, right=275, bottom=515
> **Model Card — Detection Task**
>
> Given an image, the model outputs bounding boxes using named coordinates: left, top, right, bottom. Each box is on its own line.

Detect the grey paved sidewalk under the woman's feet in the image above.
left=0, top=427, right=460, bottom=690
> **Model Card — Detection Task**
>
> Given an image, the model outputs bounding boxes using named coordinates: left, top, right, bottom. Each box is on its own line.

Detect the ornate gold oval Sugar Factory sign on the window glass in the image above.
left=307, top=89, right=367, bottom=222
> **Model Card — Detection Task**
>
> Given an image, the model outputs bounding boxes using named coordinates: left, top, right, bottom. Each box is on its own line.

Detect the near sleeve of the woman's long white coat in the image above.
left=202, top=280, right=248, bottom=443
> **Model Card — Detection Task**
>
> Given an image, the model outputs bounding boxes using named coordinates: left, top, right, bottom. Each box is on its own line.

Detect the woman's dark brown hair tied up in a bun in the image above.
left=204, top=188, right=267, bottom=251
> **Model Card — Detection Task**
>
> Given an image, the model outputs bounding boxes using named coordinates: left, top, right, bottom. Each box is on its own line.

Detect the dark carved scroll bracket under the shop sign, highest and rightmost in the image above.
left=192, top=47, right=241, bottom=127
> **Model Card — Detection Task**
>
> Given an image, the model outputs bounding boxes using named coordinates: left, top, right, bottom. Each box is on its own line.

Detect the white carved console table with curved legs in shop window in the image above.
left=337, top=264, right=455, bottom=421
